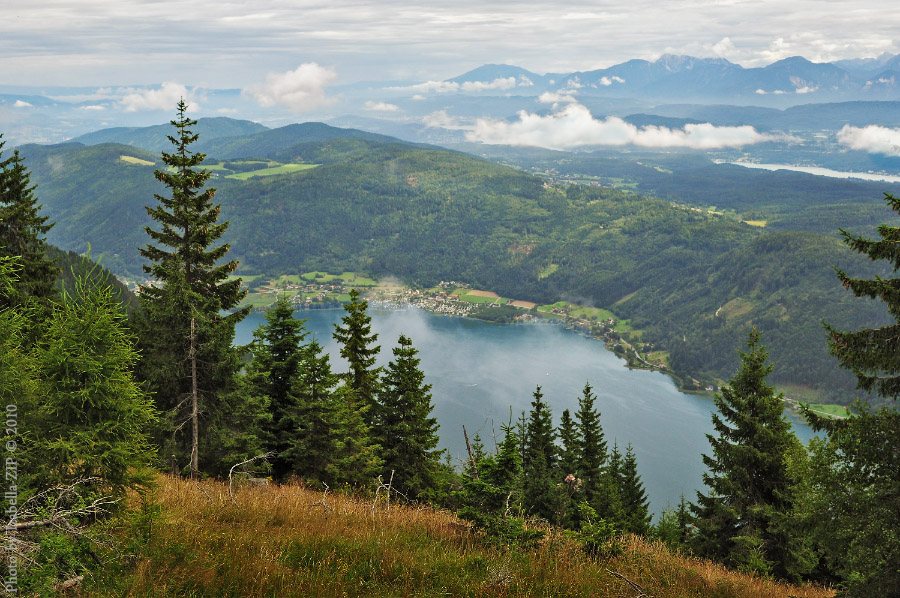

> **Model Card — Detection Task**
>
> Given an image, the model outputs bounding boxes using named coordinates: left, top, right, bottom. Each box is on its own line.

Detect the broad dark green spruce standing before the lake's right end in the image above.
left=691, top=329, right=799, bottom=578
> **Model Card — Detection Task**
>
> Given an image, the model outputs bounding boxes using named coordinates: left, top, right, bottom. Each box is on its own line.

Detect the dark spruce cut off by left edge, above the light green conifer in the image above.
left=0, top=135, right=59, bottom=307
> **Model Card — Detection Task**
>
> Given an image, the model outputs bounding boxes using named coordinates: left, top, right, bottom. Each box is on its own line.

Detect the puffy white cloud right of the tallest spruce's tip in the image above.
left=244, top=62, right=337, bottom=112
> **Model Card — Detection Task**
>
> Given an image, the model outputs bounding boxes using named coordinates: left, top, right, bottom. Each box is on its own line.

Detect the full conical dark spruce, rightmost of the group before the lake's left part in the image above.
left=372, top=334, right=443, bottom=499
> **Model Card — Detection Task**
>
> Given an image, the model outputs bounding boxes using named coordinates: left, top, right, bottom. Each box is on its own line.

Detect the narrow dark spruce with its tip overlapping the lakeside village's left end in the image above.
left=334, top=289, right=381, bottom=427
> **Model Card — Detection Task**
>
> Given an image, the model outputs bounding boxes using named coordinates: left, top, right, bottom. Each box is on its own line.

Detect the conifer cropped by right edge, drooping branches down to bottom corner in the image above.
left=807, top=193, right=900, bottom=597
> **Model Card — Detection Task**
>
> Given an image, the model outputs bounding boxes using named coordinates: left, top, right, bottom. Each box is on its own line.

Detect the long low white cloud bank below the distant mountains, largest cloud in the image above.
left=466, top=102, right=775, bottom=149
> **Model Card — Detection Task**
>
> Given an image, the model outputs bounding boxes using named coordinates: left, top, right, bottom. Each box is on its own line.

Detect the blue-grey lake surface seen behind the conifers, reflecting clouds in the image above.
left=236, top=306, right=812, bottom=513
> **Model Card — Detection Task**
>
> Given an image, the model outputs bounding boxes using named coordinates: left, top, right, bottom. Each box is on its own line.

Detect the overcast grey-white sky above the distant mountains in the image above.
left=7, top=0, right=900, bottom=89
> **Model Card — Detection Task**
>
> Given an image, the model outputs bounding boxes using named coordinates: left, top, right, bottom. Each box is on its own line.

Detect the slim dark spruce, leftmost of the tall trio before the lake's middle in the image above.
left=522, top=386, right=565, bottom=521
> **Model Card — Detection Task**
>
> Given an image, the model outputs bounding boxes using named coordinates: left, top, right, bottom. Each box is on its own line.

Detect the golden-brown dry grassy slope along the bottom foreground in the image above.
left=86, top=477, right=832, bottom=598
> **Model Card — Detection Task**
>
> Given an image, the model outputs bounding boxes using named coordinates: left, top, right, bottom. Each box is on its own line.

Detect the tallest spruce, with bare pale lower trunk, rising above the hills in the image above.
left=140, top=100, right=248, bottom=475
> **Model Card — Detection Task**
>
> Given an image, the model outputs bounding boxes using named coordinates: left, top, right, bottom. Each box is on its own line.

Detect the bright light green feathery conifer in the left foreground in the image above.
left=26, top=283, right=156, bottom=492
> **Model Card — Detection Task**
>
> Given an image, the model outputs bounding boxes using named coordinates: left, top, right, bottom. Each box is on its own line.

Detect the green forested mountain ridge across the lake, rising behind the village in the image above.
left=15, top=126, right=887, bottom=401
